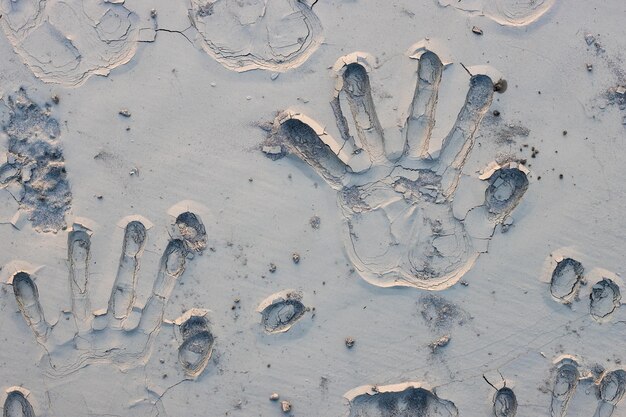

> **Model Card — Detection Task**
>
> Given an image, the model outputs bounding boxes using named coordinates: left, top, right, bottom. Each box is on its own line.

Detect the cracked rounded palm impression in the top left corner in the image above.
left=0, top=0, right=139, bottom=86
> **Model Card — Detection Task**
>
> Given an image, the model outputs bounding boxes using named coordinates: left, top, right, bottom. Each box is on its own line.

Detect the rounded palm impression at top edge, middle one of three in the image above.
left=189, top=0, right=323, bottom=72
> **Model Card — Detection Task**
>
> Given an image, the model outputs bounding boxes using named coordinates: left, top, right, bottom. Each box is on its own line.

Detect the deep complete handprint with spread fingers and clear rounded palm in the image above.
left=266, top=44, right=528, bottom=290
